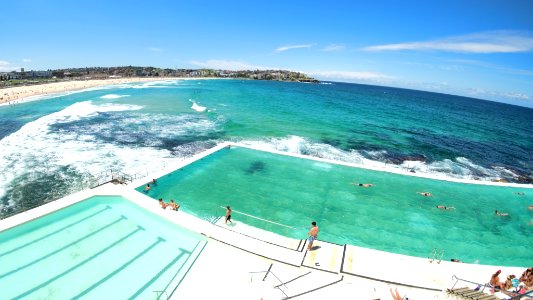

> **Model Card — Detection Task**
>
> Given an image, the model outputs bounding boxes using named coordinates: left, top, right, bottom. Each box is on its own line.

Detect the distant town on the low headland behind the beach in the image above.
left=0, top=66, right=318, bottom=88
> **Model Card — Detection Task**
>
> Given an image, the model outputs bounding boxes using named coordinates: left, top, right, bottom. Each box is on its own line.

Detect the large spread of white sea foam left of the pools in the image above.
left=0, top=101, right=178, bottom=209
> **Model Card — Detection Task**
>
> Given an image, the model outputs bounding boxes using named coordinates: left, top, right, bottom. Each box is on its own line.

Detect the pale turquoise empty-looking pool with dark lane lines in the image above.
left=0, top=196, right=207, bottom=299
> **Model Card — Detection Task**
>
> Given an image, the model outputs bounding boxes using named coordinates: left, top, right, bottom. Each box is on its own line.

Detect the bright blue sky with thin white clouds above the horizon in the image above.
left=0, top=0, right=533, bottom=107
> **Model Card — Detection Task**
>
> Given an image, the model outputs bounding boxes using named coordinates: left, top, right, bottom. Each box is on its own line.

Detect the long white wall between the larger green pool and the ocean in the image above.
left=231, top=142, right=533, bottom=189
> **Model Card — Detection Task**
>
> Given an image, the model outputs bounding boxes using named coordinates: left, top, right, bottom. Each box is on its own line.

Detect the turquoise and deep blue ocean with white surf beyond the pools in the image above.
left=0, top=80, right=533, bottom=214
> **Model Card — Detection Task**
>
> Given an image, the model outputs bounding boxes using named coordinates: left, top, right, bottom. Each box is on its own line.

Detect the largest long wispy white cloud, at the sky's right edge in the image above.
left=363, top=31, right=533, bottom=53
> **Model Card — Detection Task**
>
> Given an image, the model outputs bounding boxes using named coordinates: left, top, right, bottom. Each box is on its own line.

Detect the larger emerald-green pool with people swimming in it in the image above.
left=137, top=147, right=533, bottom=266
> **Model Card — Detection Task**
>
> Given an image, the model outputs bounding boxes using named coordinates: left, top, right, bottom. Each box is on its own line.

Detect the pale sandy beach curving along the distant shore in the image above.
left=0, top=77, right=181, bottom=104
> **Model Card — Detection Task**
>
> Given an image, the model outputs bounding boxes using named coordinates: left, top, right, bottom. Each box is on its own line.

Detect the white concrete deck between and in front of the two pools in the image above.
left=0, top=144, right=528, bottom=299
